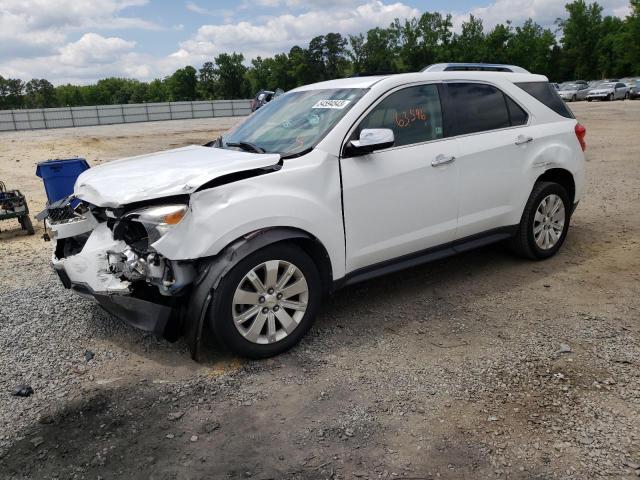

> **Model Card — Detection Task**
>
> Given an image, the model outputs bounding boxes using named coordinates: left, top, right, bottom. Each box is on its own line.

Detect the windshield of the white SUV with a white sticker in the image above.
left=222, top=88, right=367, bottom=156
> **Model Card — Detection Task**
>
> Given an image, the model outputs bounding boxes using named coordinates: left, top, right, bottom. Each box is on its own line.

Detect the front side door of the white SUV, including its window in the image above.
left=340, top=83, right=458, bottom=272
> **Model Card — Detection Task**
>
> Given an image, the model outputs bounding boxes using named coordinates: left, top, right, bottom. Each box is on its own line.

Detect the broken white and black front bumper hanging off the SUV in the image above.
left=52, top=223, right=178, bottom=335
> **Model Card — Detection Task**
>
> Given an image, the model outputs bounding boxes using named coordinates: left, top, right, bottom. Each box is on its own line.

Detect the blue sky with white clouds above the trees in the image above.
left=0, top=0, right=628, bottom=84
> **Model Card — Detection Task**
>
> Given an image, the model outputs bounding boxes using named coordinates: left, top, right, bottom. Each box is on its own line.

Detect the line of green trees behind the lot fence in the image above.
left=0, top=0, right=640, bottom=109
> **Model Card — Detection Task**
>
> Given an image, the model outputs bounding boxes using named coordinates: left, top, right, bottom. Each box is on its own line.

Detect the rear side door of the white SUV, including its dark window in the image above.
left=446, top=82, right=534, bottom=239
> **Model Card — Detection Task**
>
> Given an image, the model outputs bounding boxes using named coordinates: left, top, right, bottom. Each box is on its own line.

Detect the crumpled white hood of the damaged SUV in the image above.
left=74, top=145, right=280, bottom=207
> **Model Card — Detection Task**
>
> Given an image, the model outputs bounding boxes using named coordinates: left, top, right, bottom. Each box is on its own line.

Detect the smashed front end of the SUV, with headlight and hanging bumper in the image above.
left=46, top=198, right=196, bottom=338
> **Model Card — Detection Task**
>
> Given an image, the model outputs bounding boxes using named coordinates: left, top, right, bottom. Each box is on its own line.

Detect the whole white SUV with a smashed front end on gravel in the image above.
left=48, top=66, right=585, bottom=358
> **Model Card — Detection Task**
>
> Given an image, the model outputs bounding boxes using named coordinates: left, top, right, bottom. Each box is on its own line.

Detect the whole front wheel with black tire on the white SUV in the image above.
left=208, top=243, right=322, bottom=359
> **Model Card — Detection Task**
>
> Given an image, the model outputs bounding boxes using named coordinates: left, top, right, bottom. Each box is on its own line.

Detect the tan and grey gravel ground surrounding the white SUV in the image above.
left=0, top=106, right=640, bottom=479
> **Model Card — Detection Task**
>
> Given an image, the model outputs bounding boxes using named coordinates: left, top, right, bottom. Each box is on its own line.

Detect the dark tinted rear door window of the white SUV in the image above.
left=447, top=83, right=511, bottom=135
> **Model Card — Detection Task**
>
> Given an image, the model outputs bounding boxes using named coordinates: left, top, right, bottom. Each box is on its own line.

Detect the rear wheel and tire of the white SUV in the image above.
left=511, top=182, right=573, bottom=260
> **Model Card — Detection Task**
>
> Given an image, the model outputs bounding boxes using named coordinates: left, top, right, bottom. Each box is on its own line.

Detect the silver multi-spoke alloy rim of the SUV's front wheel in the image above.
left=231, top=260, right=309, bottom=344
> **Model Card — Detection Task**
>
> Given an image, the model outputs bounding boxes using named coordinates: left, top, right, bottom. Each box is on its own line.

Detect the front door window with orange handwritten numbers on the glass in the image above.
left=354, top=85, right=443, bottom=146
